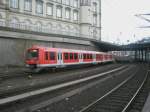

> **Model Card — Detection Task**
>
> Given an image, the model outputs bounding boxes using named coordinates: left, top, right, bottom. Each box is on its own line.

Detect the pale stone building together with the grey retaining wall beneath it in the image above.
left=0, top=0, right=101, bottom=66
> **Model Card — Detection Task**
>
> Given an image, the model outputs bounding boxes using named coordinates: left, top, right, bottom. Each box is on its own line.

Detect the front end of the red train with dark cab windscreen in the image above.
left=26, top=47, right=59, bottom=68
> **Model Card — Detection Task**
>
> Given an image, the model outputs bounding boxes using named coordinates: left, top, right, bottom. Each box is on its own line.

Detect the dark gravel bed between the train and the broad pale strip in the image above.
left=0, top=64, right=121, bottom=98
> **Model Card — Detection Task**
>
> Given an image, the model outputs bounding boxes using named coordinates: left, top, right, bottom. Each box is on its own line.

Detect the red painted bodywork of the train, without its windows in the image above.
left=26, top=46, right=113, bottom=66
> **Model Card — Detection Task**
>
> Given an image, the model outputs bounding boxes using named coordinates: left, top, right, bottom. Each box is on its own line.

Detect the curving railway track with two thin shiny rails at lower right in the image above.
left=80, top=65, right=150, bottom=112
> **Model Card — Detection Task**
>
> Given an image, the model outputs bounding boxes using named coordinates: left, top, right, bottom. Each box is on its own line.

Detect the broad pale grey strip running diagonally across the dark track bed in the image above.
left=0, top=66, right=126, bottom=105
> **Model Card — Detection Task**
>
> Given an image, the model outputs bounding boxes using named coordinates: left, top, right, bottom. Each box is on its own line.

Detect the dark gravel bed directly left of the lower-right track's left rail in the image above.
left=34, top=64, right=139, bottom=112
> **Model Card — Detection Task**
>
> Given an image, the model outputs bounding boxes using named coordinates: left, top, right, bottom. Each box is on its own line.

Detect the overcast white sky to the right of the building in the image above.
left=101, top=0, right=150, bottom=44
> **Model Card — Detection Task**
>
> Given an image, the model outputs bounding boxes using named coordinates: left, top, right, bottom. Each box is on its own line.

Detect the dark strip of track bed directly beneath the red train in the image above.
left=0, top=63, right=117, bottom=80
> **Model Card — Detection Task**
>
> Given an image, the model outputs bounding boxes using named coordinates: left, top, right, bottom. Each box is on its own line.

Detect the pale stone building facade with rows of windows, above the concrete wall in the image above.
left=0, top=0, right=101, bottom=40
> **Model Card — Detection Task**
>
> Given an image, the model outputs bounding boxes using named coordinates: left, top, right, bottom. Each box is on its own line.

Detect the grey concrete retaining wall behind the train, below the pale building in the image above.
left=0, top=38, right=98, bottom=67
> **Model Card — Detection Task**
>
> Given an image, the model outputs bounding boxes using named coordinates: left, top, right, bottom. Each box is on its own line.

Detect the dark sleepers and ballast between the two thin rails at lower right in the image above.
left=82, top=66, right=147, bottom=112
